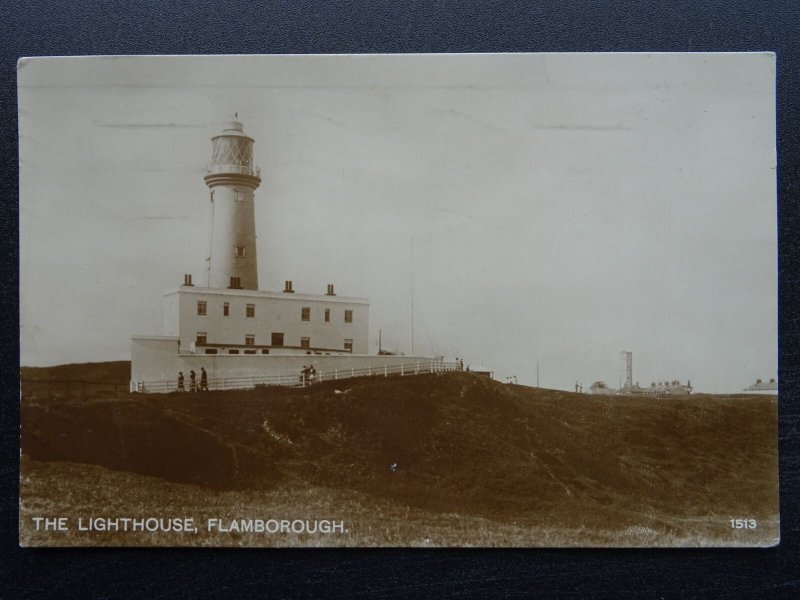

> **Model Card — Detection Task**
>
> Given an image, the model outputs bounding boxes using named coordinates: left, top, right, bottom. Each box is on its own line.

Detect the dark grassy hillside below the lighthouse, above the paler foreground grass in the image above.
left=22, top=373, right=778, bottom=545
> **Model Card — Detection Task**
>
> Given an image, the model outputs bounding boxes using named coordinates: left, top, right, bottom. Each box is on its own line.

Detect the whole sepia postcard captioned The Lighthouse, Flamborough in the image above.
left=18, top=53, right=780, bottom=547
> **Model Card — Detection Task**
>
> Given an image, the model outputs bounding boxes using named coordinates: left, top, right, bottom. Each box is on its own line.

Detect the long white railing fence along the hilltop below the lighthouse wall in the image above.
left=131, top=360, right=462, bottom=394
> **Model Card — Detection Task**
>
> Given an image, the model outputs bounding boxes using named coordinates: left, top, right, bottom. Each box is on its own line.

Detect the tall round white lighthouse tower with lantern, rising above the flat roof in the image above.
left=205, top=115, right=261, bottom=290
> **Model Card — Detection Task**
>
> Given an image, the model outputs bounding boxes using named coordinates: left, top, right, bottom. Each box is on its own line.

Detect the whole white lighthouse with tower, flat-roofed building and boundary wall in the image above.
left=131, top=120, right=434, bottom=391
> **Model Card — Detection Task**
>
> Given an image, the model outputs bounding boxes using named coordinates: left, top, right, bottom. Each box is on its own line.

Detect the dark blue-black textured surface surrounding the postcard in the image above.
left=0, top=0, right=800, bottom=598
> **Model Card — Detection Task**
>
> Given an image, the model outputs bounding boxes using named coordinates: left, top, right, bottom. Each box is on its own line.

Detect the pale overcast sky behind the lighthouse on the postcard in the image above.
left=19, top=54, right=777, bottom=392
